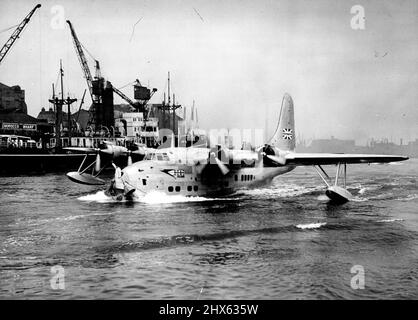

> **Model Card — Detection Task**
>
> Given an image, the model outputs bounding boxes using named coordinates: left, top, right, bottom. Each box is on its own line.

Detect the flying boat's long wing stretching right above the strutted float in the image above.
left=285, top=153, right=409, bottom=166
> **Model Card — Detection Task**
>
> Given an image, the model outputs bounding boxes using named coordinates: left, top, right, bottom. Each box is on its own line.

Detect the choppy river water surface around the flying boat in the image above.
left=0, top=160, right=418, bottom=299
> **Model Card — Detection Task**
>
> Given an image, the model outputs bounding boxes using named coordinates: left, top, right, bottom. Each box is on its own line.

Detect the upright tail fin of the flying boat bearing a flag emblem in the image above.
left=268, top=93, right=296, bottom=151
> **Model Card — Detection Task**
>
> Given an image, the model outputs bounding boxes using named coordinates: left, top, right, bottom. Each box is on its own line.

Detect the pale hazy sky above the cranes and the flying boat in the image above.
left=0, top=0, right=418, bottom=143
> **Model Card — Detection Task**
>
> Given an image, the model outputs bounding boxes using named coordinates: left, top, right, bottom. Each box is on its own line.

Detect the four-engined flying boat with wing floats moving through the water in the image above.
left=67, top=94, right=408, bottom=203
